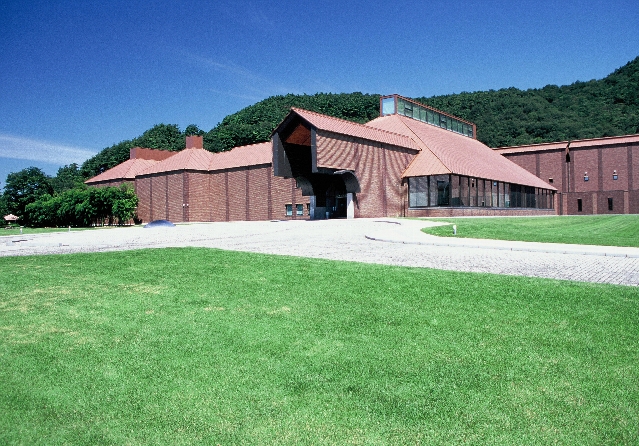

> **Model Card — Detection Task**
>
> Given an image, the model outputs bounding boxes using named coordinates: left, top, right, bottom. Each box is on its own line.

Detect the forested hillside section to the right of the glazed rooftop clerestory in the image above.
left=415, top=57, right=639, bottom=147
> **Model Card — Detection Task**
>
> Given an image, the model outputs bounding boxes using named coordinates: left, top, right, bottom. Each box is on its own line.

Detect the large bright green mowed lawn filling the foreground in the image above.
left=0, top=248, right=639, bottom=445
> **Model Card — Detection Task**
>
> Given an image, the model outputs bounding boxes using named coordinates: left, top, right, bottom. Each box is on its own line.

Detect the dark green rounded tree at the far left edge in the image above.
left=3, top=167, right=53, bottom=223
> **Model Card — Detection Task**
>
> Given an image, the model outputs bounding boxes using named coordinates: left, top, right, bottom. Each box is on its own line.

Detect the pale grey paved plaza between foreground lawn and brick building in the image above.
left=0, top=218, right=639, bottom=286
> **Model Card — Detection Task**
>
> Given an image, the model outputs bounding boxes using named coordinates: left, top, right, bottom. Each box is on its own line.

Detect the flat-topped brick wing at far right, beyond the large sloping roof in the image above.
left=495, top=135, right=639, bottom=215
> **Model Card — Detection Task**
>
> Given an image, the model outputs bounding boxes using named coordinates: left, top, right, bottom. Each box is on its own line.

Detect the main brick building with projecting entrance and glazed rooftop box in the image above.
left=87, top=95, right=557, bottom=222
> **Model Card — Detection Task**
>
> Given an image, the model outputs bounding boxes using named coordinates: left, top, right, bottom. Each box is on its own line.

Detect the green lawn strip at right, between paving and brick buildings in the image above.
left=422, top=215, right=639, bottom=247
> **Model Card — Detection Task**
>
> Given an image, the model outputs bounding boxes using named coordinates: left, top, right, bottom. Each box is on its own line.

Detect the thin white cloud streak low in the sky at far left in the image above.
left=0, top=133, right=96, bottom=165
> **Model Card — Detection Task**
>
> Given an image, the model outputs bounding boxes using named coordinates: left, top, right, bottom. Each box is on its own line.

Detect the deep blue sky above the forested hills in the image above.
left=0, top=0, right=639, bottom=187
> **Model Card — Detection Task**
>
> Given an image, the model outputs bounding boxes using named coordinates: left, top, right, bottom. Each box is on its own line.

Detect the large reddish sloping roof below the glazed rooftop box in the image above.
left=367, top=115, right=554, bottom=189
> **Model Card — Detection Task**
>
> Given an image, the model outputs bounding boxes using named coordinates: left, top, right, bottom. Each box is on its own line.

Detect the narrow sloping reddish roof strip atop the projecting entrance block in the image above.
left=291, top=108, right=420, bottom=150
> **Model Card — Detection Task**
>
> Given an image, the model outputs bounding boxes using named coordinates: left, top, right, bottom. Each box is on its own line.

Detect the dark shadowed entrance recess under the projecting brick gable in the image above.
left=273, top=116, right=360, bottom=218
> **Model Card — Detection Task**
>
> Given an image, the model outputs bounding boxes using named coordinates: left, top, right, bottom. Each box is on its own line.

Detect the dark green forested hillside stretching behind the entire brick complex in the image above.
left=81, top=57, right=639, bottom=178
